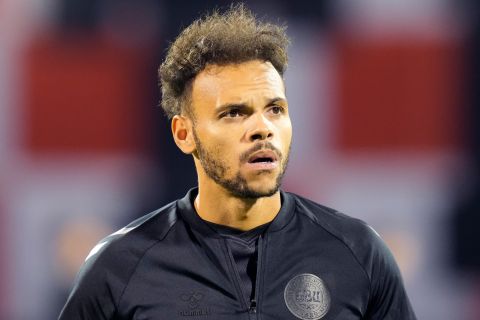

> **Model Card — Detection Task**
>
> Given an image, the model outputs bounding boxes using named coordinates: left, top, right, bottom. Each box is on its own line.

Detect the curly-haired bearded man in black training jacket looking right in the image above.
left=60, top=6, right=415, bottom=320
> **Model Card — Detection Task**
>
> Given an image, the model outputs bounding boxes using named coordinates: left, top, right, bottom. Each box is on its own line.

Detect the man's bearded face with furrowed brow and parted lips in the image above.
left=191, top=60, right=292, bottom=198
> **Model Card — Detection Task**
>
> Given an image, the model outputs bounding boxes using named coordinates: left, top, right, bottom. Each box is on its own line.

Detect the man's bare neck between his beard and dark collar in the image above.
left=195, top=180, right=281, bottom=230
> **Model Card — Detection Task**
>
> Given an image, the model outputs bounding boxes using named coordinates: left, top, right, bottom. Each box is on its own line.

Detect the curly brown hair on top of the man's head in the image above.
left=158, top=4, right=289, bottom=118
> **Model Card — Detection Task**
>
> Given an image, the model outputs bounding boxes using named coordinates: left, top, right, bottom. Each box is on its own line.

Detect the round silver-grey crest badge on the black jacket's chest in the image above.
left=284, top=273, right=330, bottom=320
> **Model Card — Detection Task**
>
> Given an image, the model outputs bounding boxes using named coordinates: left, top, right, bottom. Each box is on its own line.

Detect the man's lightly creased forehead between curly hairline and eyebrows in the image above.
left=192, top=60, right=285, bottom=109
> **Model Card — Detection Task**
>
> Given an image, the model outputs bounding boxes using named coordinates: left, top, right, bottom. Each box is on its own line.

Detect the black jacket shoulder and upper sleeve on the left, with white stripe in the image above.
left=59, top=202, right=176, bottom=320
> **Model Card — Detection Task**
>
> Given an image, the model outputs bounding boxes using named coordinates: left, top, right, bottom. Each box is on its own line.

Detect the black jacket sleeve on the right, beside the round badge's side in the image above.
left=366, top=229, right=416, bottom=320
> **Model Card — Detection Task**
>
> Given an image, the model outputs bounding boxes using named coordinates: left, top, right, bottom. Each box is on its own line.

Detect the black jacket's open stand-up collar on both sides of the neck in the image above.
left=177, top=188, right=295, bottom=237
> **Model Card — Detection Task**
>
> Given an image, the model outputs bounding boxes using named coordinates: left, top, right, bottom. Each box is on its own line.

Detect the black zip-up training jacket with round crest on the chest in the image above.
left=59, top=189, right=416, bottom=320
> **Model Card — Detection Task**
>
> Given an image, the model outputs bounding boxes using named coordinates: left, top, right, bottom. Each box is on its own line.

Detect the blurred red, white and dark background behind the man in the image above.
left=0, top=0, right=480, bottom=320
